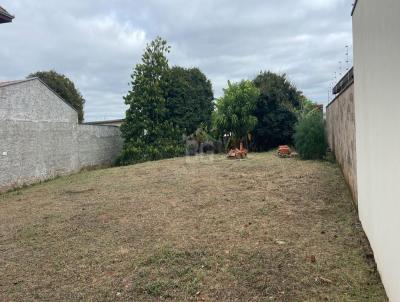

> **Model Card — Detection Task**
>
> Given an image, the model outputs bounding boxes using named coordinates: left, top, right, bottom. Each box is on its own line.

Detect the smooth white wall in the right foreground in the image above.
left=353, top=0, right=400, bottom=302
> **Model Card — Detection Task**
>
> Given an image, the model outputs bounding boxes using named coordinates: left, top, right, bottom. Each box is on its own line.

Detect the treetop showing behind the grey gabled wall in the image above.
left=28, top=70, right=85, bottom=123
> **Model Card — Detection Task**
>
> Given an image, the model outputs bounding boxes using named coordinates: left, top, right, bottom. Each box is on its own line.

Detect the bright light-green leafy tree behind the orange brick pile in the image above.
left=213, top=81, right=260, bottom=147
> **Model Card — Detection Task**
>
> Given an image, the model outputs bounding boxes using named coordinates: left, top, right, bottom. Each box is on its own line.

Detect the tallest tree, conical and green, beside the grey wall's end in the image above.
left=119, top=37, right=185, bottom=165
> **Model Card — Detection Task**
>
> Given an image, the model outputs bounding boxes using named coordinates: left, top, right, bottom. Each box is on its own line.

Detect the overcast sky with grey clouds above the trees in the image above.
left=0, top=0, right=353, bottom=121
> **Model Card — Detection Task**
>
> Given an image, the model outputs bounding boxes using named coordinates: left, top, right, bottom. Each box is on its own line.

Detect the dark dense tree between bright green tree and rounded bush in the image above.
left=251, top=72, right=304, bottom=151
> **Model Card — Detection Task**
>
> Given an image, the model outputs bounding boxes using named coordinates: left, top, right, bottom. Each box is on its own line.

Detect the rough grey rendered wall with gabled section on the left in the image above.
left=0, top=79, right=121, bottom=191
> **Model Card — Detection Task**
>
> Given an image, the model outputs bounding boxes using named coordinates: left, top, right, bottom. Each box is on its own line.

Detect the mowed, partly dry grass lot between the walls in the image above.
left=0, top=153, right=387, bottom=301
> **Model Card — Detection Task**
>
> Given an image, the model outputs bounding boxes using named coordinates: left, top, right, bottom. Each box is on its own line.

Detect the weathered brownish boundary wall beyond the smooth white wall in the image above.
left=326, top=84, right=357, bottom=203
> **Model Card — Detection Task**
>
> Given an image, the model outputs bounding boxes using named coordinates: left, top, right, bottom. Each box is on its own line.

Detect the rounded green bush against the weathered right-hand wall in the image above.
left=294, top=111, right=327, bottom=159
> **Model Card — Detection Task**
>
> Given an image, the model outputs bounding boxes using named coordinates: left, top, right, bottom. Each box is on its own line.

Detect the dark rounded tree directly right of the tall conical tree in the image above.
left=166, top=67, right=214, bottom=135
